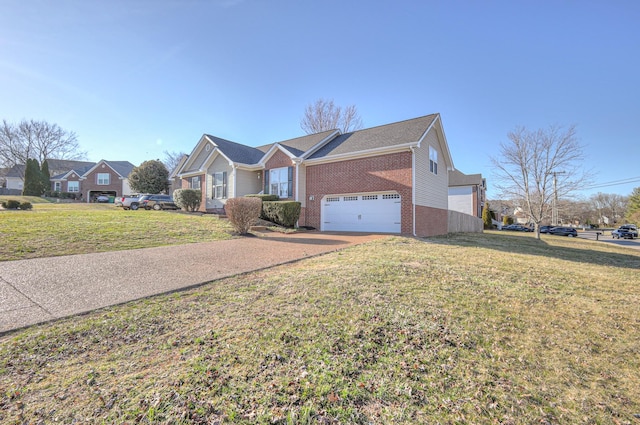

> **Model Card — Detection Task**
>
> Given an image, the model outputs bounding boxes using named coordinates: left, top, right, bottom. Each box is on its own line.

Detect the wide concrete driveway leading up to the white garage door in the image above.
left=0, top=232, right=384, bottom=334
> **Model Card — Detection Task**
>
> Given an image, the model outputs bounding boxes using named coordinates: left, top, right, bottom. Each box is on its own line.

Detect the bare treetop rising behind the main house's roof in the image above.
left=300, top=99, right=362, bottom=134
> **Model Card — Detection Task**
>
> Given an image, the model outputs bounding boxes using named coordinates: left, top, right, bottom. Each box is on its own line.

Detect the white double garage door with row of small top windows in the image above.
left=322, top=193, right=401, bottom=233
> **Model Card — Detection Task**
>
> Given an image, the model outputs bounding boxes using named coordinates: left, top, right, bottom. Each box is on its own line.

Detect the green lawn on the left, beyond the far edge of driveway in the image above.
left=0, top=197, right=232, bottom=261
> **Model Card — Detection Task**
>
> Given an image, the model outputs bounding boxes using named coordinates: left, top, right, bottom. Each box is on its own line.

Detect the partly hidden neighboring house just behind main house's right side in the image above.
left=449, top=170, right=487, bottom=218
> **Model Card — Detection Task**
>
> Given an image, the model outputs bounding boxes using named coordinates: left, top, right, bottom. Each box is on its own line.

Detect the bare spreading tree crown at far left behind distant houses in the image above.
left=0, top=120, right=86, bottom=167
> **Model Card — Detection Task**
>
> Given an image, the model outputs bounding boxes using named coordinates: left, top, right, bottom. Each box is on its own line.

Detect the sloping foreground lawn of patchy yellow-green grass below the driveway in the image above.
left=0, top=233, right=640, bottom=424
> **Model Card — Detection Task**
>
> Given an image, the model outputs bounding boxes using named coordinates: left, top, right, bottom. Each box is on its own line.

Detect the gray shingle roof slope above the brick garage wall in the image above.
left=309, top=114, right=438, bottom=159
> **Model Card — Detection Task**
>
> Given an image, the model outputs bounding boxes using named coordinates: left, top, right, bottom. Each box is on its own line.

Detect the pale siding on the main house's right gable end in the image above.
left=415, top=128, right=449, bottom=210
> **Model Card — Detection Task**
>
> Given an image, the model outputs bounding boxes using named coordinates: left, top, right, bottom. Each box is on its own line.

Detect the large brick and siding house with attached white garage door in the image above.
left=176, top=114, right=464, bottom=236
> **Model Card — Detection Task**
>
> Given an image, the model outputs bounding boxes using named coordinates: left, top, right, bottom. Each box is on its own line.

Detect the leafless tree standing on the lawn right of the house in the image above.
left=491, top=126, right=588, bottom=238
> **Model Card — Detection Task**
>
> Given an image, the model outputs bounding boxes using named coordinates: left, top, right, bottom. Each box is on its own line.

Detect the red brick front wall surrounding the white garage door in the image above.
left=300, top=152, right=416, bottom=234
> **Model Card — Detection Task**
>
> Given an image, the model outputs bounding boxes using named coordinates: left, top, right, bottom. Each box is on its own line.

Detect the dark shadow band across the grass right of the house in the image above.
left=425, top=233, right=640, bottom=269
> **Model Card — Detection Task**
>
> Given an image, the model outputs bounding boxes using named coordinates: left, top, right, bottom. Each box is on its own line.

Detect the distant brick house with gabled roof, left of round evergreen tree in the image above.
left=51, top=160, right=134, bottom=202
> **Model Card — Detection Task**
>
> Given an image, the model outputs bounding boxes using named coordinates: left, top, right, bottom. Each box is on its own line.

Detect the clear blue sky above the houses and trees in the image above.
left=0, top=0, right=640, bottom=198
